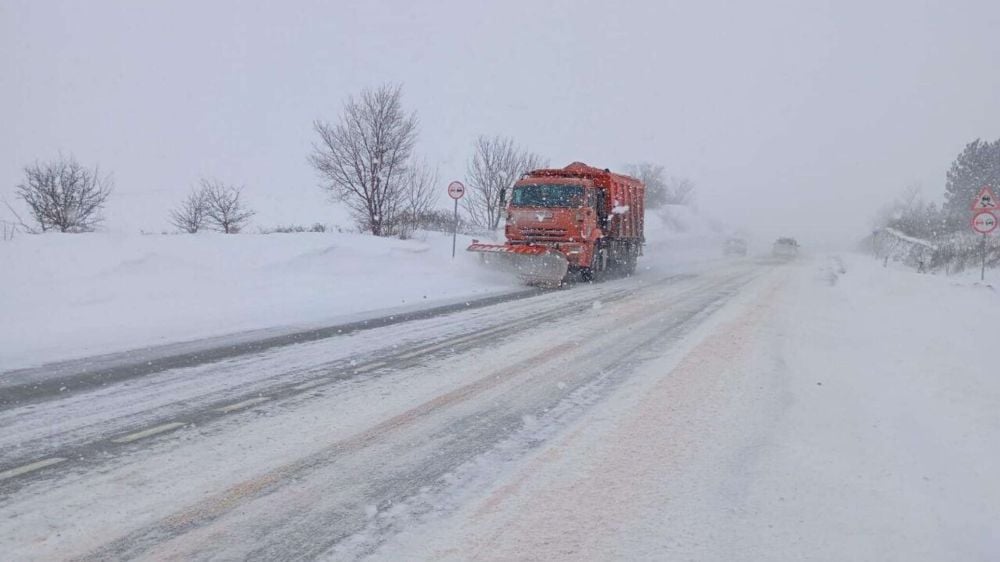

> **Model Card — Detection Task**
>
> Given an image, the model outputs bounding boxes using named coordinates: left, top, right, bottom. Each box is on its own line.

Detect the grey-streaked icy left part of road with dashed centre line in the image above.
left=0, top=262, right=771, bottom=559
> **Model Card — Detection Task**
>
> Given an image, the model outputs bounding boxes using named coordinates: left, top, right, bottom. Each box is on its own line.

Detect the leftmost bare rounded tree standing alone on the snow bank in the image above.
left=17, top=157, right=114, bottom=232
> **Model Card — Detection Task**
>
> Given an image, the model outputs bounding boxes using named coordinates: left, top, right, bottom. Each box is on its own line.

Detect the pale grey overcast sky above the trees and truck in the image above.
left=0, top=0, right=1000, bottom=242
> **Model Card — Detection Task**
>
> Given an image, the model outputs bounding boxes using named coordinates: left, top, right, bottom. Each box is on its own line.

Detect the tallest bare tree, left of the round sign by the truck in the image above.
left=309, top=85, right=417, bottom=236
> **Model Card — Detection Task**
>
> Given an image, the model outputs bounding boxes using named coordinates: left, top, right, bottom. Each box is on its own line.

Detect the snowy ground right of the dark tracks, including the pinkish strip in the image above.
left=376, top=256, right=1000, bottom=560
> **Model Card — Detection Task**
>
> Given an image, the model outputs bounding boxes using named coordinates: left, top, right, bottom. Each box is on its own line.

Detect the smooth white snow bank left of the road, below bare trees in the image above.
left=0, top=233, right=517, bottom=372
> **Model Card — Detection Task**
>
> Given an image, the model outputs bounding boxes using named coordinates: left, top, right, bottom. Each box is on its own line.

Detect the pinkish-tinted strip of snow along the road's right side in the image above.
left=412, top=276, right=780, bottom=561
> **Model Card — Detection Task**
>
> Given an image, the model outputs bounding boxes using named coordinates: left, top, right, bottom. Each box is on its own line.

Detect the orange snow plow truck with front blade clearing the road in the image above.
left=468, top=162, right=646, bottom=287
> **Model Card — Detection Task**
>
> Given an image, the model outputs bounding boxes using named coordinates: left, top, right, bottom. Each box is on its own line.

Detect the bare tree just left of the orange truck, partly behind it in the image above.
left=462, top=135, right=548, bottom=230
